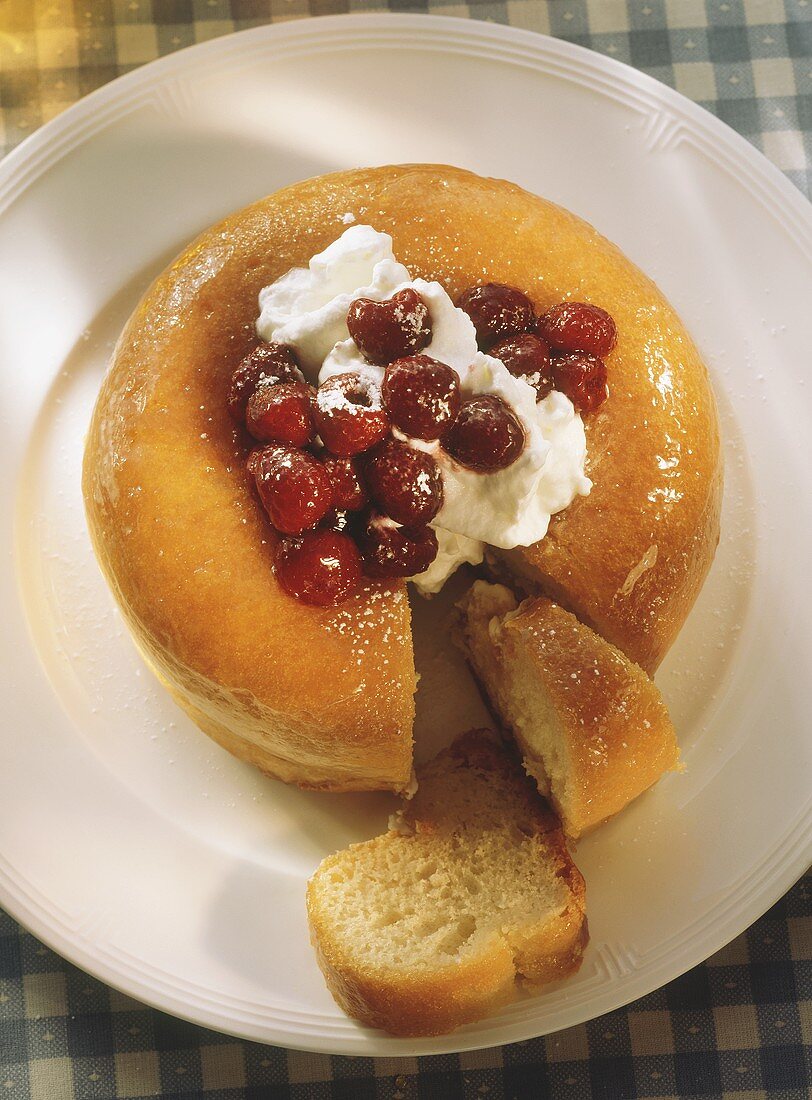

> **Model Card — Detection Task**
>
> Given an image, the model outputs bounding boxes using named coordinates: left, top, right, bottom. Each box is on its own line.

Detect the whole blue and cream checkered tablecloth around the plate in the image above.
left=0, top=0, right=812, bottom=1100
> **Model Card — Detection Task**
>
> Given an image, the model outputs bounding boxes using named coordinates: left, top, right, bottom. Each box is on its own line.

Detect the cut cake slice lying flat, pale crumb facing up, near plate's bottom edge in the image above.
left=307, top=730, right=588, bottom=1036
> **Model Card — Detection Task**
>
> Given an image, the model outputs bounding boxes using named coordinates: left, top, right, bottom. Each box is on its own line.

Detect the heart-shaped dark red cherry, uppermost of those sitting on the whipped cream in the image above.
left=347, top=287, right=431, bottom=366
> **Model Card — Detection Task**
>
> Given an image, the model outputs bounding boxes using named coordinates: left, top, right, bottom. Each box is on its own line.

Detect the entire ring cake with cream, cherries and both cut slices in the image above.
left=84, top=165, right=722, bottom=1034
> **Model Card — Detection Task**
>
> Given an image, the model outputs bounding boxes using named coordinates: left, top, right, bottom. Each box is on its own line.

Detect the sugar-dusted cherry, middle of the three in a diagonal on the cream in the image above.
left=381, top=355, right=460, bottom=439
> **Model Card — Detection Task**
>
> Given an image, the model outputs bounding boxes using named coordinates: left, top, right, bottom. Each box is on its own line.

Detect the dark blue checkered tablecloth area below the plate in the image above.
left=0, top=875, right=812, bottom=1100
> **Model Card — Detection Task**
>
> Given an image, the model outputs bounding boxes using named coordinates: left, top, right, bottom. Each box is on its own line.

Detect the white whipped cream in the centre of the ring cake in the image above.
left=256, top=226, right=592, bottom=595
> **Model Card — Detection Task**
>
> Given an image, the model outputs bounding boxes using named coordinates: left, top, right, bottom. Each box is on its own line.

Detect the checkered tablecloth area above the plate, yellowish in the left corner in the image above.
left=0, top=0, right=812, bottom=194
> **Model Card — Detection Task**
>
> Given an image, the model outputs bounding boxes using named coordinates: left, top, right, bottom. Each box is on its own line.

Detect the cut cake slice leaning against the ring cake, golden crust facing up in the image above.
left=456, top=581, right=679, bottom=837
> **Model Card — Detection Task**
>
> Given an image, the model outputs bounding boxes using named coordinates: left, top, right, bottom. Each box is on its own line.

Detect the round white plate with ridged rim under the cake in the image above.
left=0, top=15, right=812, bottom=1055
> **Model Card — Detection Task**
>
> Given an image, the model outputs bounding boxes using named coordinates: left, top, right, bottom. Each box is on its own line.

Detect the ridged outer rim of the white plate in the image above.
left=0, top=12, right=812, bottom=1056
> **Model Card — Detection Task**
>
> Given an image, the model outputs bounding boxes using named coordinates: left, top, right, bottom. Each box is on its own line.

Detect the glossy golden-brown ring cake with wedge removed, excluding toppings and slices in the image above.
left=84, top=165, right=721, bottom=790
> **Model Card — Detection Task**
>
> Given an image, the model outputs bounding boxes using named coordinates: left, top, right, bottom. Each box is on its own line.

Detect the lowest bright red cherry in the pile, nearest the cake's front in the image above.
left=274, top=529, right=362, bottom=607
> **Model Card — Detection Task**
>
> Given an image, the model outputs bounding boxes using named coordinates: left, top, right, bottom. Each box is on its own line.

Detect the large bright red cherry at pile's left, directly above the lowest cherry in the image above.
left=248, top=443, right=333, bottom=535
